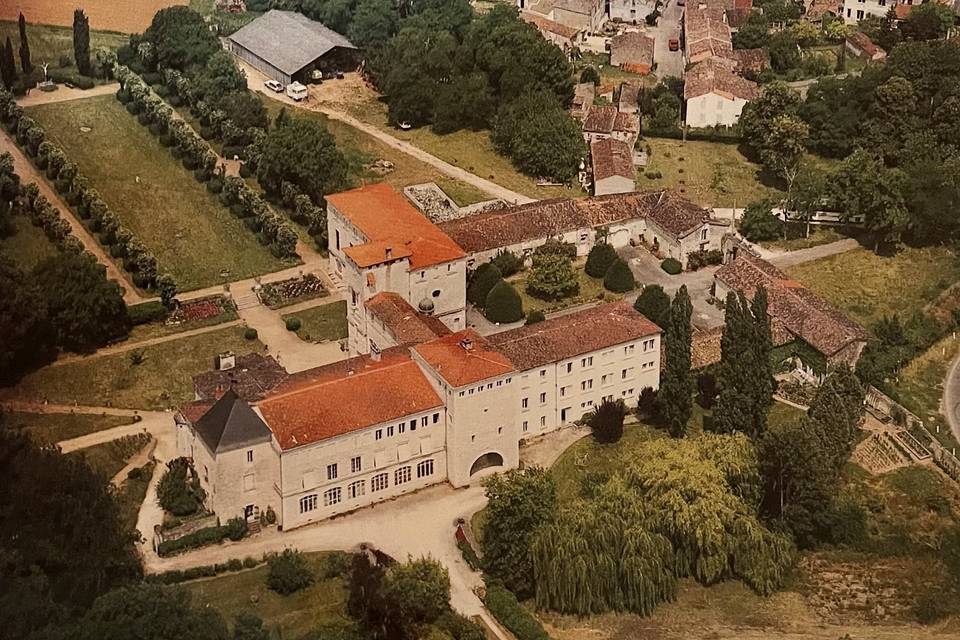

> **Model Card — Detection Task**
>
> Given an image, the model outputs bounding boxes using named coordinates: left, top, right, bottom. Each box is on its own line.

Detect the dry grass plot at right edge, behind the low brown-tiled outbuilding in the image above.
left=786, top=247, right=960, bottom=327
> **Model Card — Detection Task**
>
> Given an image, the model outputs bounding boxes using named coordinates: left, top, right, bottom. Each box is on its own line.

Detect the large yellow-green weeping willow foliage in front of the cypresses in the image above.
left=531, top=435, right=794, bottom=615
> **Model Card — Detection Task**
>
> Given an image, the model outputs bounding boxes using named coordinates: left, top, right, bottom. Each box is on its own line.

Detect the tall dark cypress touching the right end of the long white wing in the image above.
left=659, top=285, right=693, bottom=438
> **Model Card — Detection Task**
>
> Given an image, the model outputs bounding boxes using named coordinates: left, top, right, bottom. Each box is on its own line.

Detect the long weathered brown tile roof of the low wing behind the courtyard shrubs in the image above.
left=440, top=189, right=710, bottom=253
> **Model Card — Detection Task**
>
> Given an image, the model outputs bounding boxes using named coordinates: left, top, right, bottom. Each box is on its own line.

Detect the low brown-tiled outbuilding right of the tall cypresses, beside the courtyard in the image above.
left=713, top=248, right=868, bottom=382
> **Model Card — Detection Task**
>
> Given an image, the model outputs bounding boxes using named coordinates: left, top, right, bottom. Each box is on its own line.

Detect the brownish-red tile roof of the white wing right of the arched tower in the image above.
left=487, top=302, right=661, bottom=371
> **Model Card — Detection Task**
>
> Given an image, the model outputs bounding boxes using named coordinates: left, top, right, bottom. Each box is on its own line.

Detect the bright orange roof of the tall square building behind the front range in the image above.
left=326, top=183, right=464, bottom=270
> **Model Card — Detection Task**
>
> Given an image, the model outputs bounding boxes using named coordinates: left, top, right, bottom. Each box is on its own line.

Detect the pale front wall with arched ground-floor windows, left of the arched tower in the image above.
left=281, top=398, right=447, bottom=529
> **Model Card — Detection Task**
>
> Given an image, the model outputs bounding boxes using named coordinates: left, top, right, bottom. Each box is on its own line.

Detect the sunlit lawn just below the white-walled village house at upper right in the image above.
left=637, top=138, right=780, bottom=208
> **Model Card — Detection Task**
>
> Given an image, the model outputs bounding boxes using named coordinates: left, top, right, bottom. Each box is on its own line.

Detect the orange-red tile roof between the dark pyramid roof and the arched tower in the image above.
left=257, top=349, right=443, bottom=450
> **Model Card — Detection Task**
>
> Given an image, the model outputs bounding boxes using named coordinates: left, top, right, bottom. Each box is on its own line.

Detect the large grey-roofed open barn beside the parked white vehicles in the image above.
left=227, top=9, right=359, bottom=84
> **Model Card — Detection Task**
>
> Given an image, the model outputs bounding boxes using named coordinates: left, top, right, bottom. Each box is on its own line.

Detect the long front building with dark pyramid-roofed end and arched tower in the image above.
left=175, top=299, right=661, bottom=530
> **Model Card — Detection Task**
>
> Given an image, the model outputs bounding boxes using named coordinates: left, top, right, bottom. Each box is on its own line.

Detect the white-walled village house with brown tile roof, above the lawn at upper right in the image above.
left=683, top=60, right=760, bottom=127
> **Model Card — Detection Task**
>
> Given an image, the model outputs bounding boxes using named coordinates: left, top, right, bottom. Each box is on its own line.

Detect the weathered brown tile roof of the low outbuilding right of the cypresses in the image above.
left=714, top=252, right=867, bottom=356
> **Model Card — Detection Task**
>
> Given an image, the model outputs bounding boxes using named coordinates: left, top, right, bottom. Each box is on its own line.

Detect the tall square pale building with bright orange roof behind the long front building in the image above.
left=326, top=183, right=466, bottom=354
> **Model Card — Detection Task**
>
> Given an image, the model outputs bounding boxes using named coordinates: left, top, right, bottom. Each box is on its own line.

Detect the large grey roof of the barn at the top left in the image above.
left=228, top=9, right=356, bottom=75
